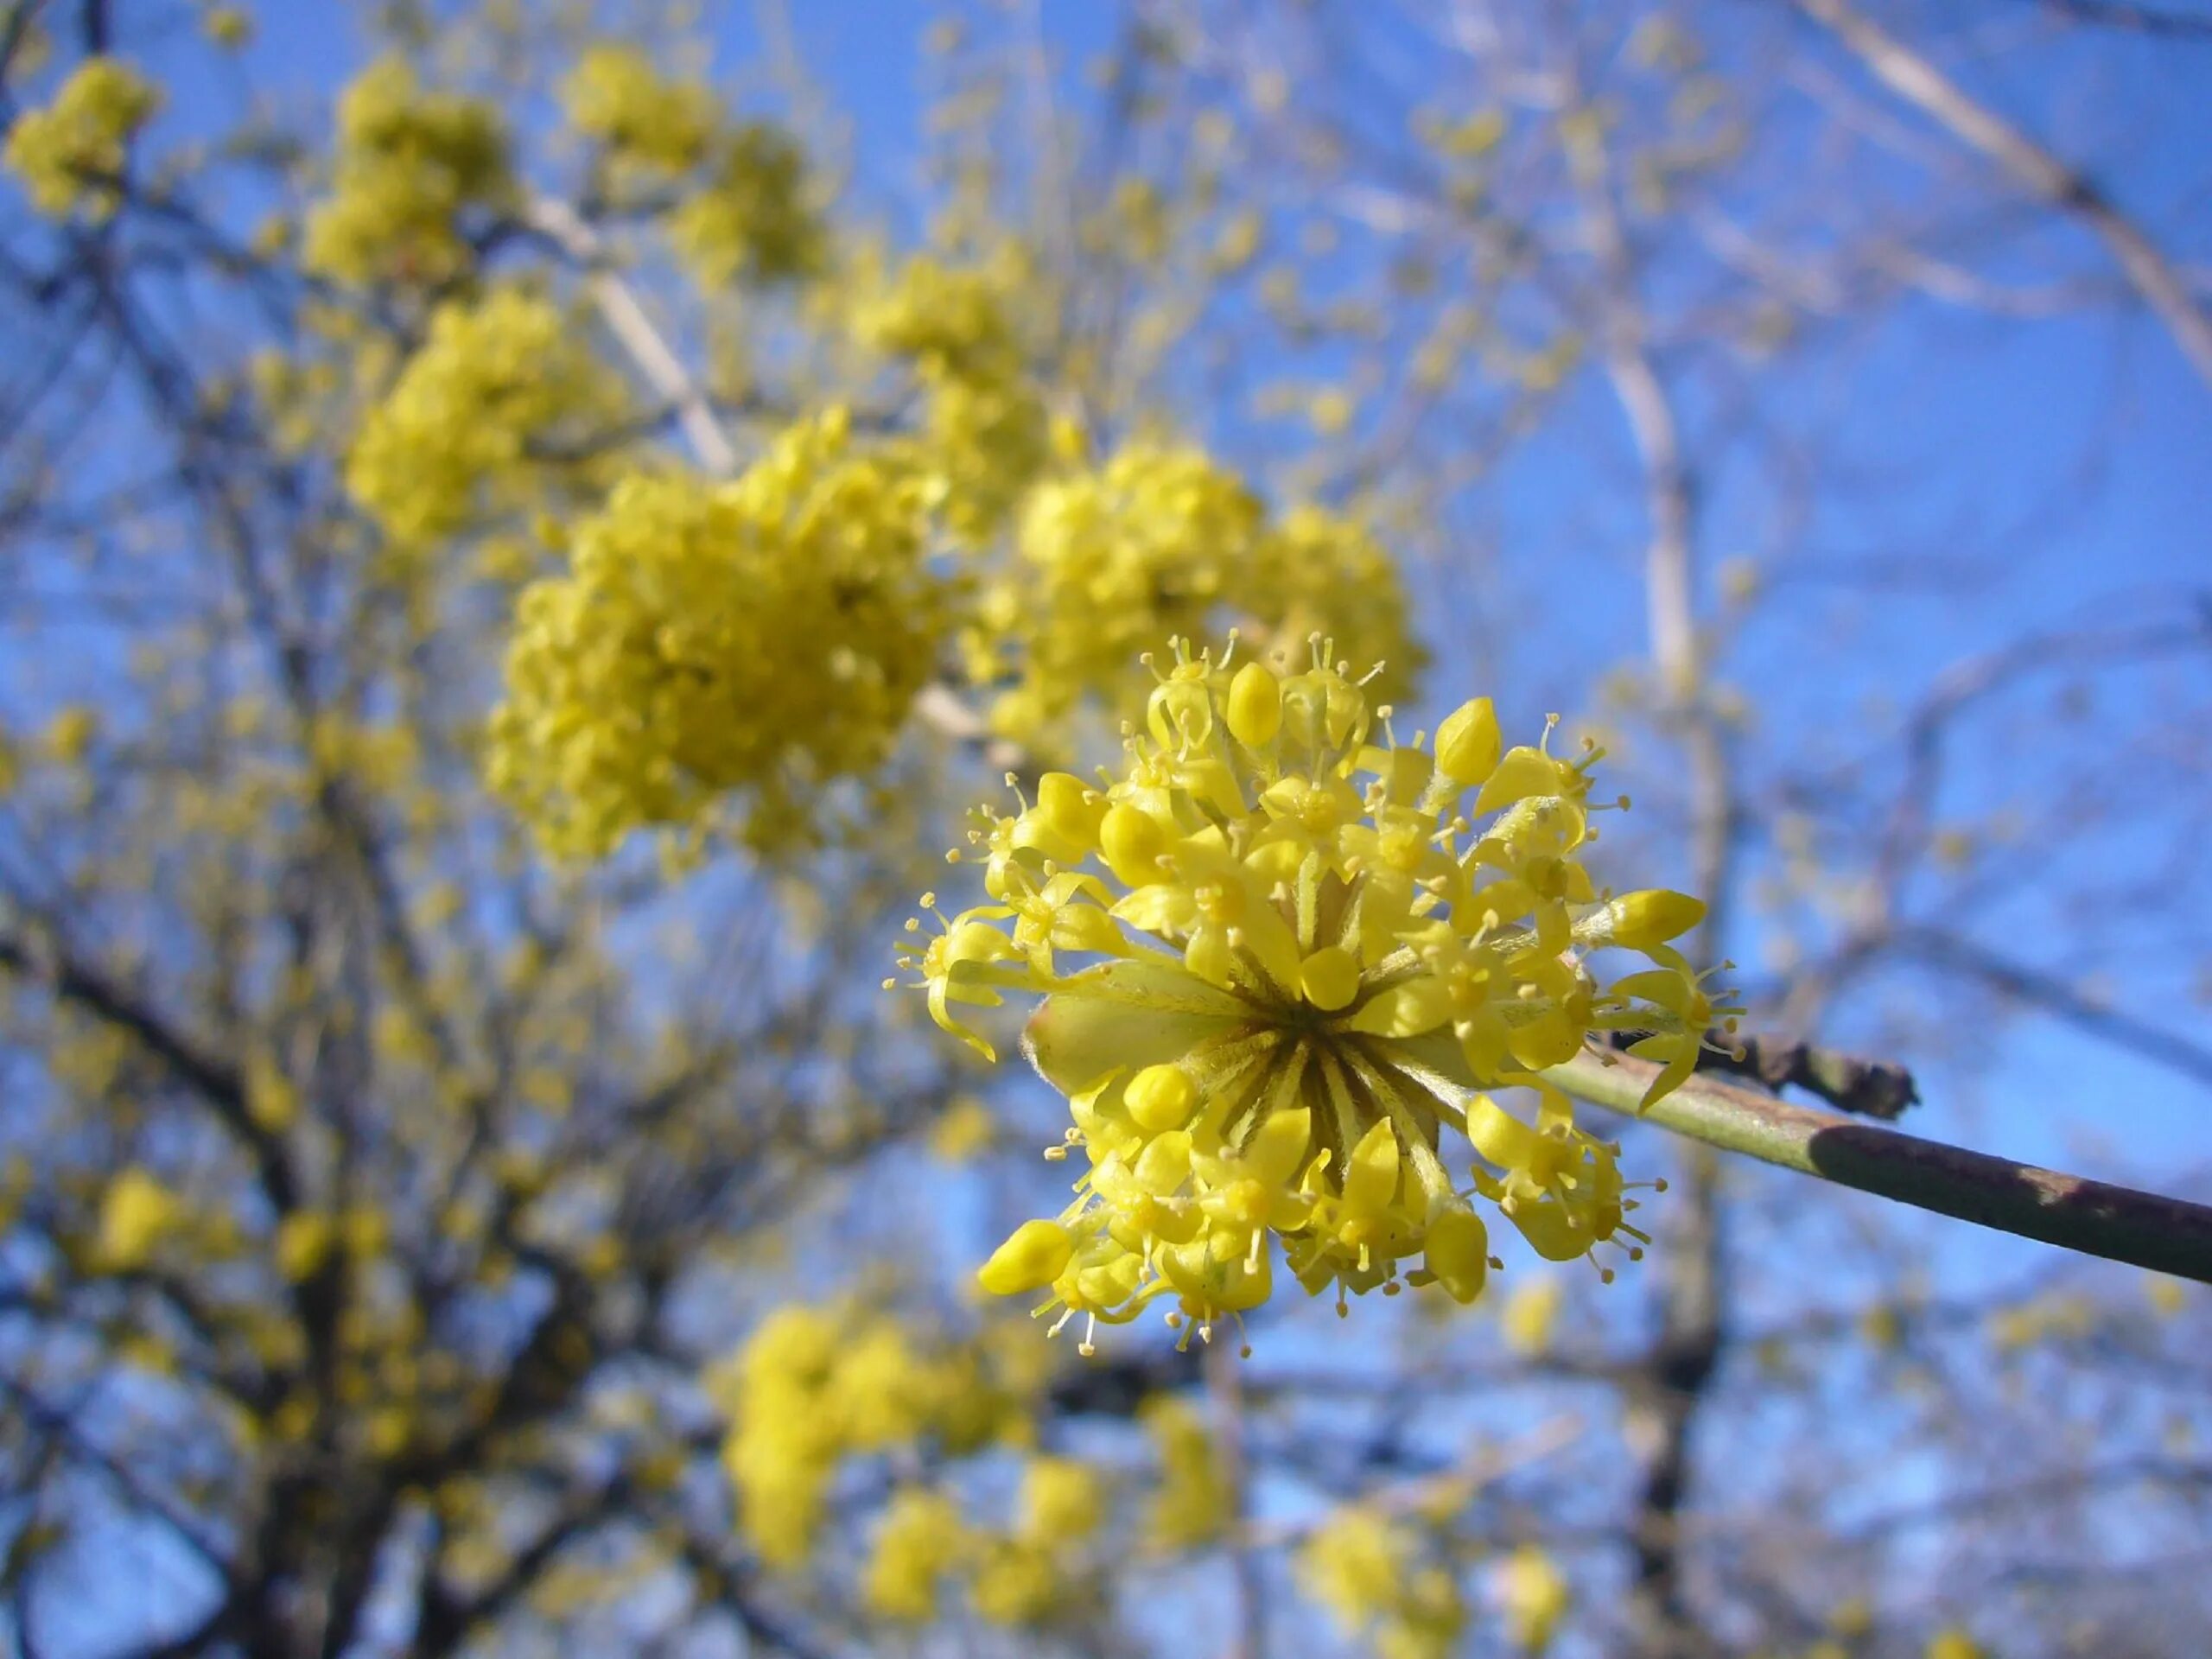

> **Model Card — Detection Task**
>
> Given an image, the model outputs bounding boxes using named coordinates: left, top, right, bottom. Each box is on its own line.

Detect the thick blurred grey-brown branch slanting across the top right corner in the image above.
left=1796, top=0, right=2212, bottom=385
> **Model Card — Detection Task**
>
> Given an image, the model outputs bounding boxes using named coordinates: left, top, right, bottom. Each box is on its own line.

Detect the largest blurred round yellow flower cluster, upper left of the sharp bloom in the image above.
left=489, top=411, right=949, bottom=856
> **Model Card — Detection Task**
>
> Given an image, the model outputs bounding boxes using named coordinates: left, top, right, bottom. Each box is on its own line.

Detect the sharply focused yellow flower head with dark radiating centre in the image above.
left=902, top=639, right=1737, bottom=1351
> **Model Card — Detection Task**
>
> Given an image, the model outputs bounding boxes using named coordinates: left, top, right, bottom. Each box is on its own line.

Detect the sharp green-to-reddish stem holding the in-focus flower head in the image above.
left=1544, top=1053, right=2212, bottom=1285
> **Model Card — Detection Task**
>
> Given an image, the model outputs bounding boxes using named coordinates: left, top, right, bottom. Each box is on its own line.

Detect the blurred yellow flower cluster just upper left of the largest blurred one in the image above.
left=345, top=288, right=617, bottom=546
